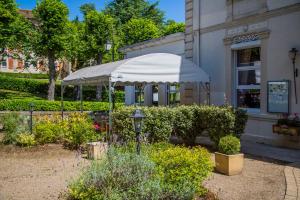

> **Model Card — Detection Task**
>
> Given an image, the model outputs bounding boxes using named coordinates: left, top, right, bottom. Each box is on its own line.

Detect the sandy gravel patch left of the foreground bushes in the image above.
left=0, top=145, right=89, bottom=200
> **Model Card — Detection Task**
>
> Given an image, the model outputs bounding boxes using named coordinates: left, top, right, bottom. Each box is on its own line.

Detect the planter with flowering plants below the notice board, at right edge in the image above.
left=273, top=113, right=300, bottom=136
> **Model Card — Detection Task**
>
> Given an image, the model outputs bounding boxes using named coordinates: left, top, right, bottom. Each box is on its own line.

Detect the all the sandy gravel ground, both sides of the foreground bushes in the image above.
left=0, top=145, right=285, bottom=200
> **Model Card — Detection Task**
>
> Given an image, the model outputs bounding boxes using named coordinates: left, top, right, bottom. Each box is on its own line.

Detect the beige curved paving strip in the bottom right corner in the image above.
left=284, top=163, right=300, bottom=200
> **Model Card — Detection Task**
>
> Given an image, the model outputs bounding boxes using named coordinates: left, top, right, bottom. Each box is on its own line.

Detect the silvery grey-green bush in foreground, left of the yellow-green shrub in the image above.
left=69, top=149, right=160, bottom=200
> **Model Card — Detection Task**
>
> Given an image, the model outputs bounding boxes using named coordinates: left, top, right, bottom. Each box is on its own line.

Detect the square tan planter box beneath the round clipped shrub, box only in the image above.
left=215, top=152, right=244, bottom=176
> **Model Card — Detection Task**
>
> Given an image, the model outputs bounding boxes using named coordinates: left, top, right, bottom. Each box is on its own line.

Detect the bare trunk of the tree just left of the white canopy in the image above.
left=48, top=53, right=56, bottom=101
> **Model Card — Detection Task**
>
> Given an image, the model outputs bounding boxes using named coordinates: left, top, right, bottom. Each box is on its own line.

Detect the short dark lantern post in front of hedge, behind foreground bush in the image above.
left=131, top=109, right=145, bottom=155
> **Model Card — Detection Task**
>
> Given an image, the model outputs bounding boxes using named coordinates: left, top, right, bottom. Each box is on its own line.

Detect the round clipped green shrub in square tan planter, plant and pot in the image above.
left=215, top=135, right=244, bottom=176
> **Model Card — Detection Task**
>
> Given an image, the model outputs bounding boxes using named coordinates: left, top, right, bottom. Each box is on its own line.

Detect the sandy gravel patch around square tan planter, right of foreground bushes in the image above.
left=204, top=156, right=286, bottom=200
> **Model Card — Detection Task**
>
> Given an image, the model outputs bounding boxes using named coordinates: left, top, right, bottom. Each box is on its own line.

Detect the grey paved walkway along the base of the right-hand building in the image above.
left=242, top=141, right=300, bottom=163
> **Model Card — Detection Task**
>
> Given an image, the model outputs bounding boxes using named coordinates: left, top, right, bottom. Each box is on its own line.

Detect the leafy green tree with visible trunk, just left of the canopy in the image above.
left=33, top=0, right=69, bottom=100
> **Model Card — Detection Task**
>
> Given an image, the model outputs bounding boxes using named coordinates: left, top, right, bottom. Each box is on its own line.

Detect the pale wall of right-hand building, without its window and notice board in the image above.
left=185, top=0, right=300, bottom=148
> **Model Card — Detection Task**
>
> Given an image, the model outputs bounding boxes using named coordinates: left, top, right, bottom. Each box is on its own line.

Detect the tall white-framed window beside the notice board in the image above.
left=236, top=47, right=261, bottom=111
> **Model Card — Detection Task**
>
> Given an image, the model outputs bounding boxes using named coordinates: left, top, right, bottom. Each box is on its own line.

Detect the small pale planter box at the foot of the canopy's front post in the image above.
left=87, top=142, right=108, bottom=160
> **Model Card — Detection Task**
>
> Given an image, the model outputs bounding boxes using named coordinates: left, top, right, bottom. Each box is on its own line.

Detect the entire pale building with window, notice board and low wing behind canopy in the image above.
left=123, top=0, right=300, bottom=149
